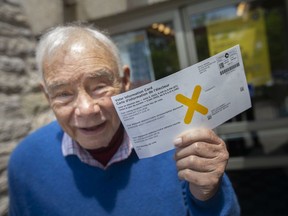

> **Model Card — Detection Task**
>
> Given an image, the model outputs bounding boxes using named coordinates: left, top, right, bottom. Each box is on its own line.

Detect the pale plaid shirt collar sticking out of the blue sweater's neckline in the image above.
left=62, top=132, right=132, bottom=169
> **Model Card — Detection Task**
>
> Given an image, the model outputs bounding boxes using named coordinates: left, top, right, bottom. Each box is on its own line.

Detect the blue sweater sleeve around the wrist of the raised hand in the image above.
left=185, top=174, right=240, bottom=216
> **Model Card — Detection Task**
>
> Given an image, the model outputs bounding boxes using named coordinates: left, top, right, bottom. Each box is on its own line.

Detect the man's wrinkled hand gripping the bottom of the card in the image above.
left=174, top=128, right=229, bottom=201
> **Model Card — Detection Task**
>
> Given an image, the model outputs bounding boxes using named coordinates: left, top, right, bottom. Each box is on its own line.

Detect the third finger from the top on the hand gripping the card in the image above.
left=176, top=155, right=218, bottom=172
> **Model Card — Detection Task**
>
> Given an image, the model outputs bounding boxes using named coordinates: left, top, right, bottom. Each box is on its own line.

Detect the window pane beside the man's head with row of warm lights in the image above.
left=112, top=22, right=180, bottom=87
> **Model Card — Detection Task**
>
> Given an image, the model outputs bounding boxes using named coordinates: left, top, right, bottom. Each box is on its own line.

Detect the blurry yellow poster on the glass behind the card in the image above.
left=207, top=9, right=271, bottom=86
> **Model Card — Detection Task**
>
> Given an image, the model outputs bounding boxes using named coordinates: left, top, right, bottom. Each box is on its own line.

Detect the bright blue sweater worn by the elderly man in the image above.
left=8, top=122, right=239, bottom=216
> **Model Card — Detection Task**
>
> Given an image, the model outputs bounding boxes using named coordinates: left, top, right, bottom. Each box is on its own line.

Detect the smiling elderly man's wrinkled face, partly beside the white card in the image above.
left=44, top=39, right=129, bottom=149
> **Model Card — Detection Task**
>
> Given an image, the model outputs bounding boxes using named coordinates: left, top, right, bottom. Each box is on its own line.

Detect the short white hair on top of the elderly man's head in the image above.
left=36, top=24, right=123, bottom=83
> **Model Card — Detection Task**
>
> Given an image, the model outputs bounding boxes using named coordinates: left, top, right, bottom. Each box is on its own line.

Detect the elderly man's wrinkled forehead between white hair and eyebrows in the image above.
left=43, top=40, right=120, bottom=91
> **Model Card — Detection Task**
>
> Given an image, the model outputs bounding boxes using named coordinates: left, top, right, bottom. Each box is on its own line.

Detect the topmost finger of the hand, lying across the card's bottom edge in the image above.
left=174, top=128, right=221, bottom=147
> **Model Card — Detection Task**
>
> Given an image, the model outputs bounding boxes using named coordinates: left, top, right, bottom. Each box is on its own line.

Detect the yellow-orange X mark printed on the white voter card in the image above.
left=176, top=85, right=208, bottom=124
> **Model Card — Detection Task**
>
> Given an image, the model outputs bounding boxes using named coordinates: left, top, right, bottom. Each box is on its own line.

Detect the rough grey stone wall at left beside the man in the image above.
left=0, top=0, right=53, bottom=216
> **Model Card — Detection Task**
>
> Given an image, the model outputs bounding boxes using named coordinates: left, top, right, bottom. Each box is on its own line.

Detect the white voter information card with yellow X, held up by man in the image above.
left=112, top=45, right=251, bottom=158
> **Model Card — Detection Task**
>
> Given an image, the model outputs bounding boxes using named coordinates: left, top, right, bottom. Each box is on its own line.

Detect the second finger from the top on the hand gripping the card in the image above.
left=175, top=142, right=223, bottom=160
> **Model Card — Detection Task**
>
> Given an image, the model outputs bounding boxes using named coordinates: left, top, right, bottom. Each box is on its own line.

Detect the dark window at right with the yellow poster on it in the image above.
left=188, top=0, right=288, bottom=159
